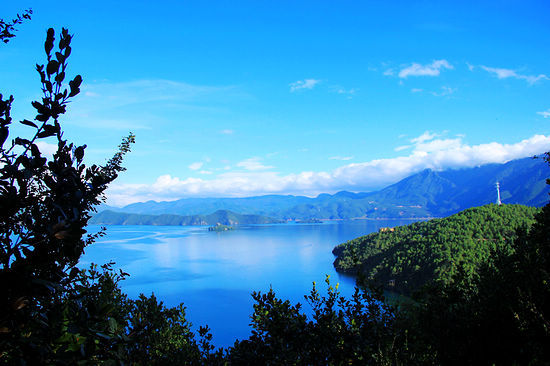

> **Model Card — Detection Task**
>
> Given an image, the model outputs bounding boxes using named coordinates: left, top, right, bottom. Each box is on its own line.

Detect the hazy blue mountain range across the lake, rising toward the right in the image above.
left=94, top=158, right=550, bottom=225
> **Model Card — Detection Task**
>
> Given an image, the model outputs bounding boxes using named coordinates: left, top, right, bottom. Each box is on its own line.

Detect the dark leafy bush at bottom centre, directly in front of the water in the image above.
left=228, top=276, right=429, bottom=365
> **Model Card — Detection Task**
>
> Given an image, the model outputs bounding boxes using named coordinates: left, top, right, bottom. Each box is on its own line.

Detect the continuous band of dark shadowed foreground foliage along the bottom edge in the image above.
left=5, top=206, right=550, bottom=365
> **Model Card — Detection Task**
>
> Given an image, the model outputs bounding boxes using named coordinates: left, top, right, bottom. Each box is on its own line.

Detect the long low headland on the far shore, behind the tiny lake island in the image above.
left=90, top=210, right=281, bottom=226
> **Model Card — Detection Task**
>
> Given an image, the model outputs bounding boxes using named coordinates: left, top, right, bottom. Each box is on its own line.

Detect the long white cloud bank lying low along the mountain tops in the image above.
left=107, top=132, right=550, bottom=205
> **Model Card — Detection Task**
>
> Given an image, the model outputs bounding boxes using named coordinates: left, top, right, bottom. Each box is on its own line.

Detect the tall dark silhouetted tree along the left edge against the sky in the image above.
left=0, top=25, right=134, bottom=363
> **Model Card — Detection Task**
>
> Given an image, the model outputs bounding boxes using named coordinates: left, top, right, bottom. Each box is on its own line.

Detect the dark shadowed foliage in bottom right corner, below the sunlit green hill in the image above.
left=408, top=205, right=550, bottom=365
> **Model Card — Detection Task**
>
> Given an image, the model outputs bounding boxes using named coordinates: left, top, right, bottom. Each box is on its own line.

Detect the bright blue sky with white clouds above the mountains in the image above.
left=0, top=0, right=550, bottom=205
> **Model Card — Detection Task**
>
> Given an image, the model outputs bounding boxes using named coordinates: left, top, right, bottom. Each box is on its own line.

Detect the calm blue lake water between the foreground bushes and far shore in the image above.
left=80, top=220, right=418, bottom=346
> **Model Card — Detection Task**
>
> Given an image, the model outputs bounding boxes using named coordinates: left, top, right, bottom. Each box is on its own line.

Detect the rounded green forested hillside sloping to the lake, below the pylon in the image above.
left=333, top=204, right=538, bottom=294
